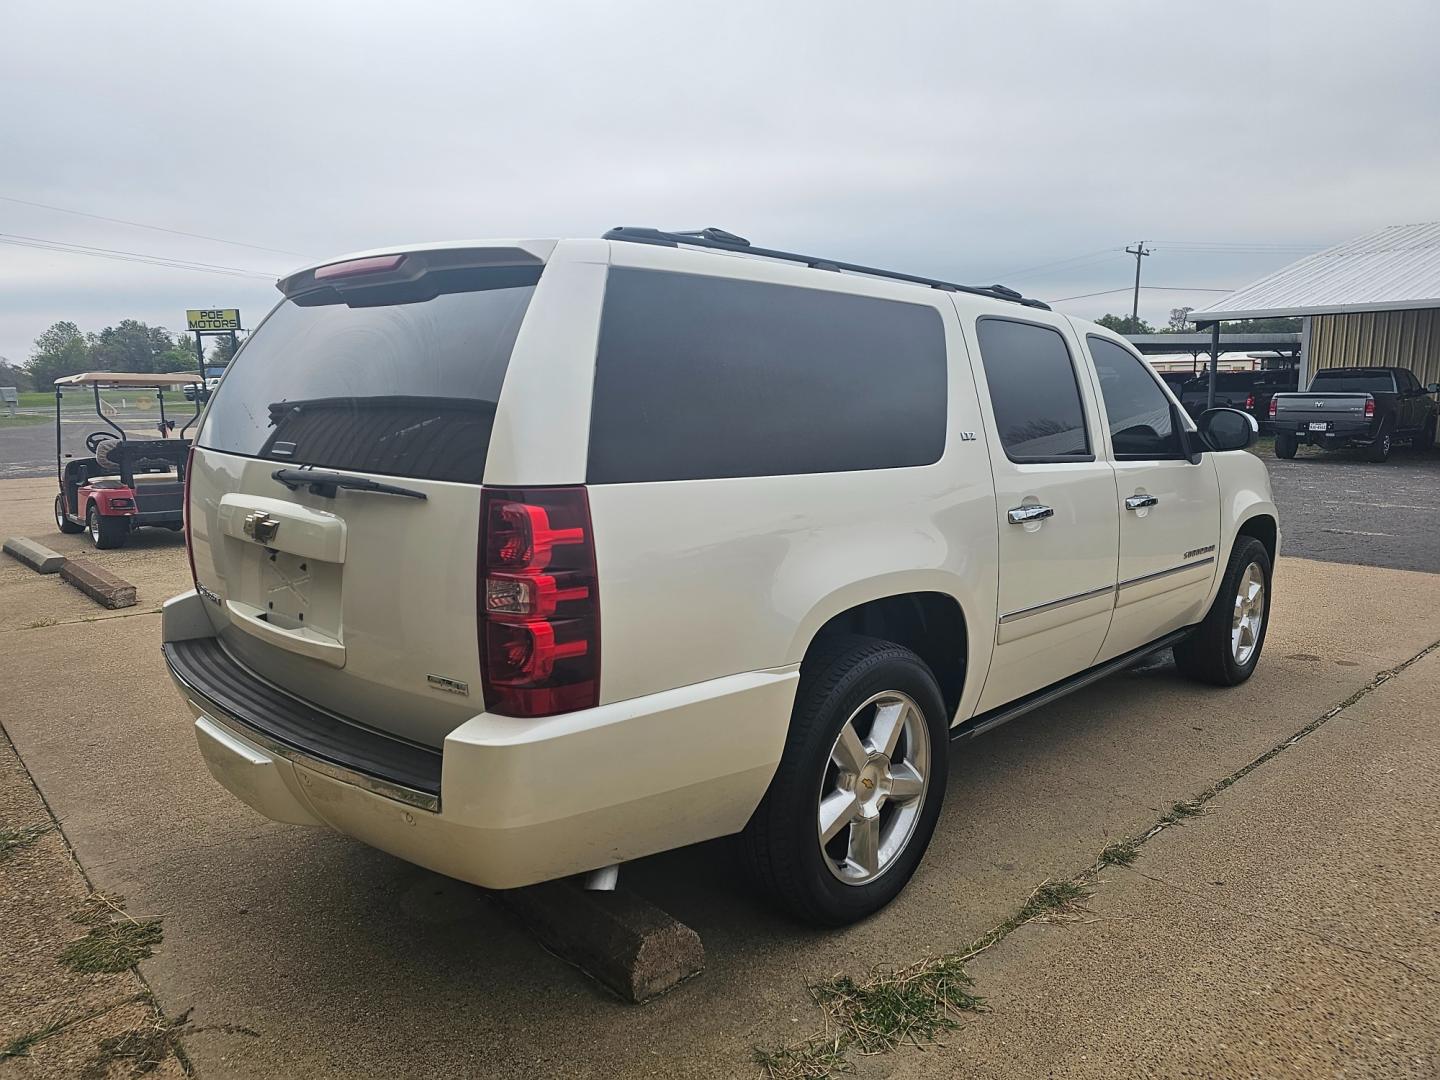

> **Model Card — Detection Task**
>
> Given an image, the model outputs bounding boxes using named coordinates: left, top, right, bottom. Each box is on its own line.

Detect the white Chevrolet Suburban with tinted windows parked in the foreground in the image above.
left=164, top=229, right=1279, bottom=924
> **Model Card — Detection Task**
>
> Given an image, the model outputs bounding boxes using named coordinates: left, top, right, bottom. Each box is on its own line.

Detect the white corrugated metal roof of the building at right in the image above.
left=1191, top=222, right=1440, bottom=321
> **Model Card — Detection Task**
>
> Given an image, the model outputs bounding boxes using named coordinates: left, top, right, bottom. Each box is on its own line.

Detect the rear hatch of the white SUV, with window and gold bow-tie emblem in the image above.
left=189, top=248, right=544, bottom=746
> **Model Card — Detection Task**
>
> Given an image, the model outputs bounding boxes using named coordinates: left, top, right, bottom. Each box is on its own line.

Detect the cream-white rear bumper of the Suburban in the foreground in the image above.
left=163, top=592, right=799, bottom=888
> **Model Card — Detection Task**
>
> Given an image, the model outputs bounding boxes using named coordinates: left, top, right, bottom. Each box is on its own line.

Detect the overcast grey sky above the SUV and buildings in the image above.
left=0, top=0, right=1440, bottom=361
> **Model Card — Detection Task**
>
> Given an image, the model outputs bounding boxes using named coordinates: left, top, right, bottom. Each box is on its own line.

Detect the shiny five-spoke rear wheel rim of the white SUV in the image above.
left=816, top=690, right=930, bottom=886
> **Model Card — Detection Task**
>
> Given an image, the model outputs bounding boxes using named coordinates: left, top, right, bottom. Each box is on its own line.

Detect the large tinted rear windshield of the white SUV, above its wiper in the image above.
left=199, top=266, right=540, bottom=484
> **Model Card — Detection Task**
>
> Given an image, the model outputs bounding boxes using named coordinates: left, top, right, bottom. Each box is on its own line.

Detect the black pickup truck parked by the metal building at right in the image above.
left=1270, top=367, right=1440, bottom=461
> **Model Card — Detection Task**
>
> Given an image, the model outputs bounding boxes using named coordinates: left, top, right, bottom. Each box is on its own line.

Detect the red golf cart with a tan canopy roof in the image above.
left=55, top=372, right=202, bottom=547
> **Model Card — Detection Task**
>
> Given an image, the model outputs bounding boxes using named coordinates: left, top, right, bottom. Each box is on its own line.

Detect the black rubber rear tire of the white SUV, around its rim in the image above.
left=740, top=635, right=949, bottom=926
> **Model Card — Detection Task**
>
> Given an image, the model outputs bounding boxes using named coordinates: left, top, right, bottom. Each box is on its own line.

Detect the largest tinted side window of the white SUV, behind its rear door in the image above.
left=589, top=266, right=946, bottom=484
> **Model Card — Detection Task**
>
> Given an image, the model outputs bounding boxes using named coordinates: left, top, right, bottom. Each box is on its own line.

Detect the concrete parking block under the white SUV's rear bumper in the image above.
left=494, top=881, right=706, bottom=1004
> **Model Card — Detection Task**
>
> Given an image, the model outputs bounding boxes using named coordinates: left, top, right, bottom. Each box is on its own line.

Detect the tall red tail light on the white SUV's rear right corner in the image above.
left=477, top=487, right=600, bottom=716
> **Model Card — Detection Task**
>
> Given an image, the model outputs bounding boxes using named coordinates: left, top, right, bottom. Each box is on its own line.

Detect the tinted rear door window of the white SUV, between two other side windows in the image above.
left=976, top=318, right=1093, bottom=461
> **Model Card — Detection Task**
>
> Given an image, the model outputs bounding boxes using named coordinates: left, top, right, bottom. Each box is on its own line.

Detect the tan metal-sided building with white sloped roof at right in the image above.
left=1191, top=222, right=1440, bottom=387
